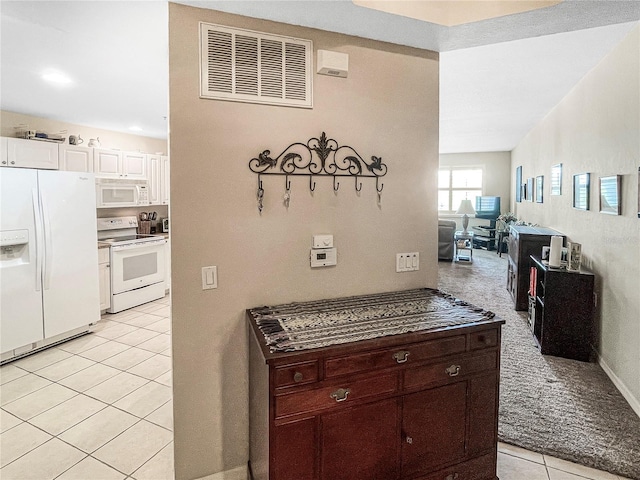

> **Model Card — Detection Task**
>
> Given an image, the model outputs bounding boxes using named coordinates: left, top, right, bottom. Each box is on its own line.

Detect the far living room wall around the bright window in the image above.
left=440, top=152, right=511, bottom=229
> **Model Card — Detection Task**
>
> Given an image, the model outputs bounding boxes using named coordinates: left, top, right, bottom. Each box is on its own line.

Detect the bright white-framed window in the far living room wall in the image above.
left=438, top=167, right=482, bottom=213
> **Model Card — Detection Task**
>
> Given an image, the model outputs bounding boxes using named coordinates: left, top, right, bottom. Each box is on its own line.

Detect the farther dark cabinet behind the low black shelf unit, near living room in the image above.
left=507, top=225, right=562, bottom=310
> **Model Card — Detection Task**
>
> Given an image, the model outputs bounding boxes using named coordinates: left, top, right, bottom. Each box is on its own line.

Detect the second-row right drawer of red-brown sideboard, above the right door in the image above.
left=404, top=352, right=498, bottom=388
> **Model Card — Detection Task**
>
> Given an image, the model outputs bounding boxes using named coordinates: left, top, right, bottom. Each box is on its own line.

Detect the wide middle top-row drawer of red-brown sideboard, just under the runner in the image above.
left=324, top=335, right=465, bottom=378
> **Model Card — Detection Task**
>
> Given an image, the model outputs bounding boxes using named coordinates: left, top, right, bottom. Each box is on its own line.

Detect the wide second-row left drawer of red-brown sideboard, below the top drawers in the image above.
left=276, top=374, right=398, bottom=418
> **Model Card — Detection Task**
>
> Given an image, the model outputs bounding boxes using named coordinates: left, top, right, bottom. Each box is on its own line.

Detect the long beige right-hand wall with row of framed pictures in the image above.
left=512, top=26, right=640, bottom=415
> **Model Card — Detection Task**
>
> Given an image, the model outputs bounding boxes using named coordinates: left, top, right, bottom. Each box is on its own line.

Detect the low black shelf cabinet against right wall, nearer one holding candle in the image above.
left=529, top=255, right=594, bottom=362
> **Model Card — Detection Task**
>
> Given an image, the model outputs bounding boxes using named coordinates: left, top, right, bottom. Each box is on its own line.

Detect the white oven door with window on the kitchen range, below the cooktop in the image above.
left=111, top=239, right=167, bottom=295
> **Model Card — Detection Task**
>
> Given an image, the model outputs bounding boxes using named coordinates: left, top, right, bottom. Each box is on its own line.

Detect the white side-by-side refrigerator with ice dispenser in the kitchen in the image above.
left=0, top=167, right=100, bottom=361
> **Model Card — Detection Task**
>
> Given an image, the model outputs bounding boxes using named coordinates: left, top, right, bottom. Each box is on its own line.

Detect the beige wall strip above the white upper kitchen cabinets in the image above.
left=0, top=110, right=167, bottom=154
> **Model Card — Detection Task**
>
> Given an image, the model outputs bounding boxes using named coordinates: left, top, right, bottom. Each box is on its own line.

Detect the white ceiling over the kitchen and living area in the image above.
left=0, top=0, right=640, bottom=153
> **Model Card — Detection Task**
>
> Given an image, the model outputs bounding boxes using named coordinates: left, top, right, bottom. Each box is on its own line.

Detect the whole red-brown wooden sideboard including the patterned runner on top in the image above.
left=247, top=289, right=504, bottom=480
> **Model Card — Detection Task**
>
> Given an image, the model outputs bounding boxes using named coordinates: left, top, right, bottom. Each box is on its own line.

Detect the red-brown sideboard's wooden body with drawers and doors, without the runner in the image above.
left=249, top=308, right=504, bottom=480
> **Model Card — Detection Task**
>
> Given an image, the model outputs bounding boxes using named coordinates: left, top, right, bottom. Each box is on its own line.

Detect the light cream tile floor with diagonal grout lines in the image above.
left=0, top=297, right=632, bottom=480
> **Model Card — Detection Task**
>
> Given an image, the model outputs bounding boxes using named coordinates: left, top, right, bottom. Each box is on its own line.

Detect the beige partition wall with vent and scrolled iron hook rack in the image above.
left=169, top=4, right=438, bottom=479
